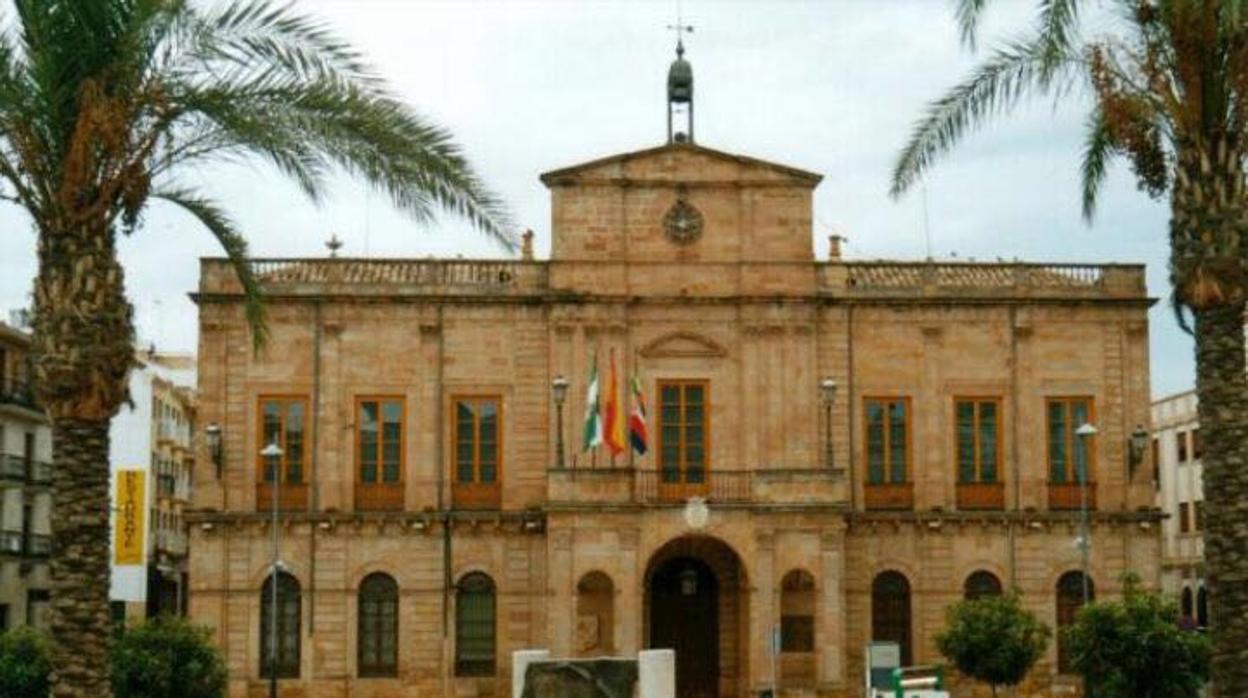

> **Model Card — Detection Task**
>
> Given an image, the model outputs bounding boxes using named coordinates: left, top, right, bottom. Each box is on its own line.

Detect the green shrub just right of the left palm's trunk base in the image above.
left=111, top=617, right=226, bottom=698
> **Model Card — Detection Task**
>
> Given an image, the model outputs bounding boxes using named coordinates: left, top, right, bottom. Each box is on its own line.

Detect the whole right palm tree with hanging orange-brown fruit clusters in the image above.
left=892, top=0, right=1248, bottom=696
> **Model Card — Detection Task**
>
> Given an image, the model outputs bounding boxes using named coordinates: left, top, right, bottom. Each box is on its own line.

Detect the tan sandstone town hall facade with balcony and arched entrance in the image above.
left=190, top=141, right=1161, bottom=698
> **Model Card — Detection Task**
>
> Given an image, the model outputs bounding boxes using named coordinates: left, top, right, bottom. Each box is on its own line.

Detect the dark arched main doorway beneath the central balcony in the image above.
left=644, top=536, right=749, bottom=698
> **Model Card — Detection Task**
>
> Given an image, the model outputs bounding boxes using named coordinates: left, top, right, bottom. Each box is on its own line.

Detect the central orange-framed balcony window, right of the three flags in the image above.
left=659, top=381, right=710, bottom=484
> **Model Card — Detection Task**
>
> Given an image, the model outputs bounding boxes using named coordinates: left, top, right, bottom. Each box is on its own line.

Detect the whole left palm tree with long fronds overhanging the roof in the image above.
left=0, top=0, right=510, bottom=698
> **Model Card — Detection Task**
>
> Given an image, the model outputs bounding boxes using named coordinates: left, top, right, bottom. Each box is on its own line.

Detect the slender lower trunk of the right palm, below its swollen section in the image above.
left=1194, top=305, right=1248, bottom=698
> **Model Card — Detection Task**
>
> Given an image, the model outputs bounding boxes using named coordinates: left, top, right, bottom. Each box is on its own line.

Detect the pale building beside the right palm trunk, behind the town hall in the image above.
left=1153, top=391, right=1208, bottom=627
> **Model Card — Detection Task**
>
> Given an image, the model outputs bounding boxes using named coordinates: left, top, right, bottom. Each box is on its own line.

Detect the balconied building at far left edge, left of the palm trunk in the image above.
left=0, top=322, right=52, bottom=631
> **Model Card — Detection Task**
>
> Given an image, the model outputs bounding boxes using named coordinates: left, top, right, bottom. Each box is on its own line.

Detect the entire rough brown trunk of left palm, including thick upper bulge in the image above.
left=34, top=219, right=134, bottom=698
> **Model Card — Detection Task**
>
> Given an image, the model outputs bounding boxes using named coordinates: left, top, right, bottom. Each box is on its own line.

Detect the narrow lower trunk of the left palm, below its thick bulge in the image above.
left=50, top=418, right=111, bottom=698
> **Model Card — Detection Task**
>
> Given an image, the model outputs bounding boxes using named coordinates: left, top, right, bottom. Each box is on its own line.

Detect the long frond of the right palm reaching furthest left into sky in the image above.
left=890, top=39, right=1080, bottom=197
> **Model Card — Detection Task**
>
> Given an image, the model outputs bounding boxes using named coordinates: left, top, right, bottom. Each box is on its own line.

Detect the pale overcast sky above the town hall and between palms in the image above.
left=0, top=0, right=1193, bottom=396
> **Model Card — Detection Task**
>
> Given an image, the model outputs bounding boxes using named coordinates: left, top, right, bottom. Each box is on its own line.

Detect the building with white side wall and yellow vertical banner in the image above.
left=109, top=351, right=196, bottom=622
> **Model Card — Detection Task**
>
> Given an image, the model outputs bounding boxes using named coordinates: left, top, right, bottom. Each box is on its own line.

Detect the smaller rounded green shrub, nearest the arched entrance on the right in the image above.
left=936, top=593, right=1051, bottom=696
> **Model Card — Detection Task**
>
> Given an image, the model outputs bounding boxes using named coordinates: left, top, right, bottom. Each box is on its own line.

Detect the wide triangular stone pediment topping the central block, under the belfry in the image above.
left=542, top=144, right=822, bottom=187
